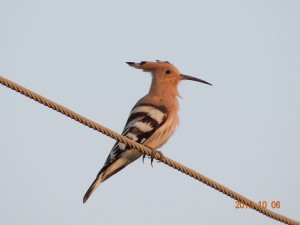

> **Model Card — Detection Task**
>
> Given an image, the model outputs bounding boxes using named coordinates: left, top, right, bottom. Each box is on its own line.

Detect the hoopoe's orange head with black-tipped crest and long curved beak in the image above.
left=126, top=60, right=211, bottom=85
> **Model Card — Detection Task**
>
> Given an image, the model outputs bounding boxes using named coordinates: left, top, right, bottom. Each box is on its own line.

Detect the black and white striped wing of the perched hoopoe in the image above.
left=99, top=104, right=168, bottom=174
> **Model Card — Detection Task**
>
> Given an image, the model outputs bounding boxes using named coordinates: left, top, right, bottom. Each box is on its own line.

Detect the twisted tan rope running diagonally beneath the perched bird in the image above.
left=0, top=76, right=300, bottom=225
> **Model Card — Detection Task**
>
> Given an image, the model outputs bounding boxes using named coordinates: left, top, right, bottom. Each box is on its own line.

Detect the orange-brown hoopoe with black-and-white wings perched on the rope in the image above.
left=83, top=60, right=211, bottom=203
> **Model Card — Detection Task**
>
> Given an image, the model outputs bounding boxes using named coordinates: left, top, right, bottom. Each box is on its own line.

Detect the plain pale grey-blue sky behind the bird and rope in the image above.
left=0, top=0, right=300, bottom=225
